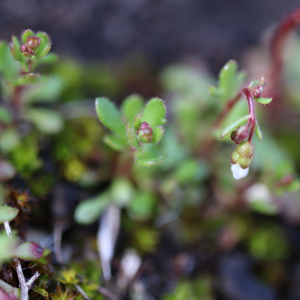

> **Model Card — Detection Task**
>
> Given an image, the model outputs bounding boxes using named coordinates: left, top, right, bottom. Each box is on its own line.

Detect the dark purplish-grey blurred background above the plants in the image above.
left=0, top=0, right=299, bottom=74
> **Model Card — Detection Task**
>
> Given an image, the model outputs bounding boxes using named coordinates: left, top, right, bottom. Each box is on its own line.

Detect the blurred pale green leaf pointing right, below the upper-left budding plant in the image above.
left=24, top=108, right=63, bottom=134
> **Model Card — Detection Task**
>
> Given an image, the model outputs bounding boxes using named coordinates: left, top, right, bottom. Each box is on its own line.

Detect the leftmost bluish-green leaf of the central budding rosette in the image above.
left=96, top=97, right=125, bottom=138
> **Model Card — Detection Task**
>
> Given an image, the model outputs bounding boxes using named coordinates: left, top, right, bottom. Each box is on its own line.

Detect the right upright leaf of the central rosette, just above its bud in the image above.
left=142, top=98, right=166, bottom=128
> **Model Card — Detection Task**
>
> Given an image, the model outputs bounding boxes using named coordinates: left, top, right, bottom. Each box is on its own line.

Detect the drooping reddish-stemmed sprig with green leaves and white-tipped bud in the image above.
left=210, top=61, right=272, bottom=179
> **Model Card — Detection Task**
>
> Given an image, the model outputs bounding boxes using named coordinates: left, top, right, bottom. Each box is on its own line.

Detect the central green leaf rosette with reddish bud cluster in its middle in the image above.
left=96, top=95, right=167, bottom=166
